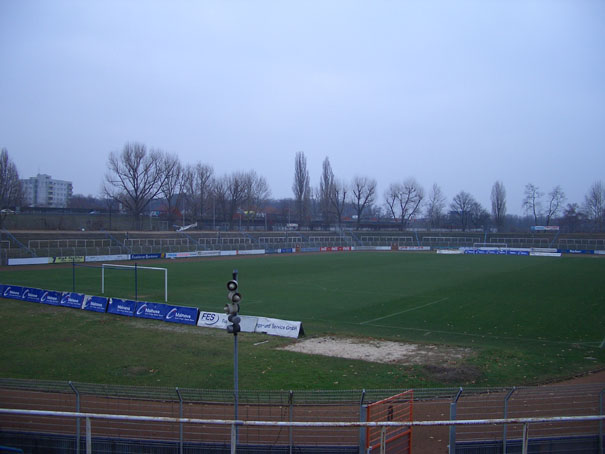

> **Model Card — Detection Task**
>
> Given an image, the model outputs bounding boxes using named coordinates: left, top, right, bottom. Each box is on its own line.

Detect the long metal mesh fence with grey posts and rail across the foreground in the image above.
left=0, top=379, right=605, bottom=454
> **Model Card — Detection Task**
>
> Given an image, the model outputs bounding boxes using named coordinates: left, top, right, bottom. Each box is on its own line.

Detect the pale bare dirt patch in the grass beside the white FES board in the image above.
left=284, top=337, right=472, bottom=369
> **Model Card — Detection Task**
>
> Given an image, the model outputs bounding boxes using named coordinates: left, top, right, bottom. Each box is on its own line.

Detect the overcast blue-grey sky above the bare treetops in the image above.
left=0, top=0, right=605, bottom=213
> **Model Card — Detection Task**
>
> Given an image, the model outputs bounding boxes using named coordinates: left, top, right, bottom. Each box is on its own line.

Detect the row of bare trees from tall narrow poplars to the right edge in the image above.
left=292, top=152, right=605, bottom=231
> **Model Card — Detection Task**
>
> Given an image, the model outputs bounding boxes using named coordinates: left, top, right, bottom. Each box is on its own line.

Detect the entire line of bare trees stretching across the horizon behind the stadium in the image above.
left=0, top=142, right=605, bottom=231
